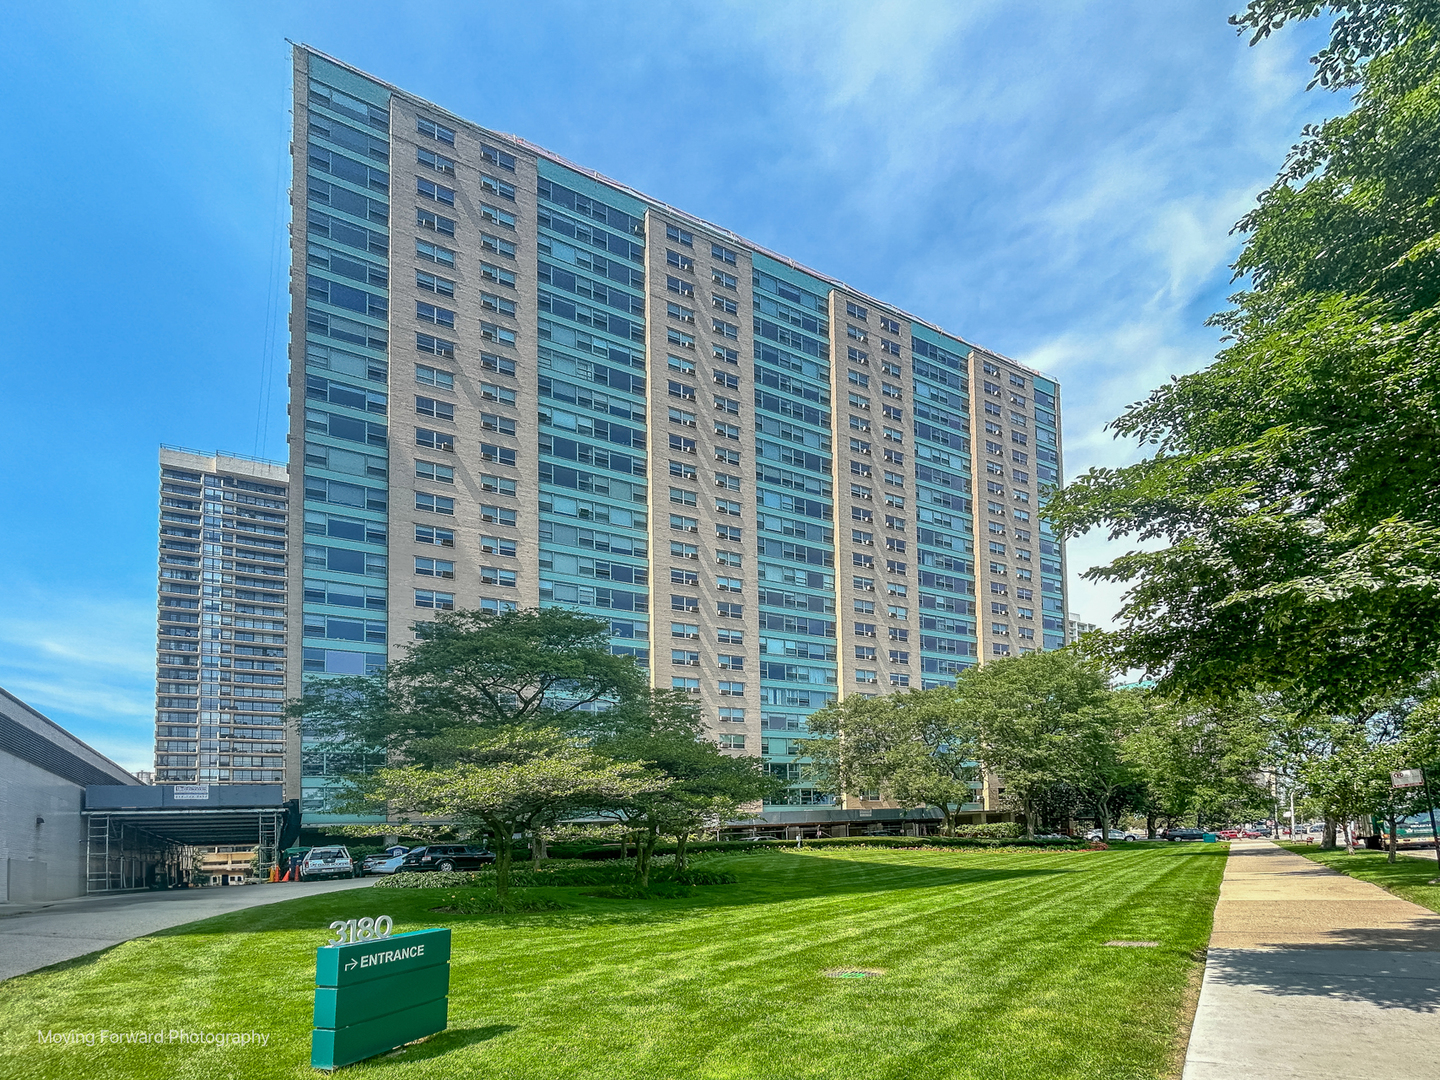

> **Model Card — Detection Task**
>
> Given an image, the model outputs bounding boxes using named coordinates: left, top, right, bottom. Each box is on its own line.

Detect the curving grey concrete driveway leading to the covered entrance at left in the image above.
left=0, top=877, right=374, bottom=981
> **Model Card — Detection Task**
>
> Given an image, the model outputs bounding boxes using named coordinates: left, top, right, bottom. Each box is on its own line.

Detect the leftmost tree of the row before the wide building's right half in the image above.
left=806, top=688, right=979, bottom=837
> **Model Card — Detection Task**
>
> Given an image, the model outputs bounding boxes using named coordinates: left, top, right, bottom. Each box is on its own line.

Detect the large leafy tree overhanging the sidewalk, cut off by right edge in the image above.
left=1050, top=0, right=1440, bottom=714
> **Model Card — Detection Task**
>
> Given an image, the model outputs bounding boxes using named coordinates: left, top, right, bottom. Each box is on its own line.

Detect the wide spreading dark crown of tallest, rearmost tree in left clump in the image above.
left=289, top=608, right=647, bottom=765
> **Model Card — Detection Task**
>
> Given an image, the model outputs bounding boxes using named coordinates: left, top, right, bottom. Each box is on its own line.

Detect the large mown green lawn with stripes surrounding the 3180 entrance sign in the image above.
left=0, top=844, right=1225, bottom=1080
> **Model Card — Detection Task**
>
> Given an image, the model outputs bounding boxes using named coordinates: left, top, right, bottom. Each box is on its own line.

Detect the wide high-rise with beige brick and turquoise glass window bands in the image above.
left=287, top=46, right=1066, bottom=824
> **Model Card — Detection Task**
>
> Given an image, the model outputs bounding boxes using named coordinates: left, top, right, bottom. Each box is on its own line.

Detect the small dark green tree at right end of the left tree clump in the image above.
left=593, top=691, right=783, bottom=888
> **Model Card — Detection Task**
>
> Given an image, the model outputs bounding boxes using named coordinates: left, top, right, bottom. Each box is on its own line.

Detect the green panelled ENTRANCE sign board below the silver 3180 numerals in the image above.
left=310, top=929, right=451, bottom=1068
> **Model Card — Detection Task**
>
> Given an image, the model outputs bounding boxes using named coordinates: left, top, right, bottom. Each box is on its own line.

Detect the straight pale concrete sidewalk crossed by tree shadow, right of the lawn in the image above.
left=1184, top=841, right=1440, bottom=1080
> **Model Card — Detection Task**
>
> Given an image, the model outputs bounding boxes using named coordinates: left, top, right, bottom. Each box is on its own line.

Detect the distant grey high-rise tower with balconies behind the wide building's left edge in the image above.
left=154, top=446, right=289, bottom=783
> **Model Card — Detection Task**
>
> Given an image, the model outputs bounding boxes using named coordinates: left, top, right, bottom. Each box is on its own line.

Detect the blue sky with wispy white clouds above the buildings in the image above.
left=0, top=0, right=1344, bottom=768
